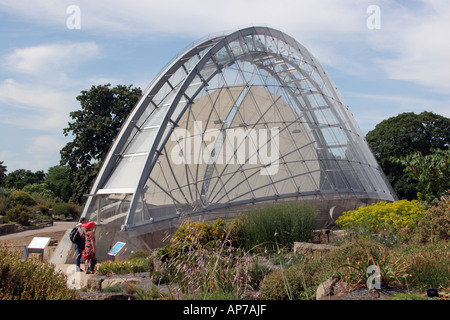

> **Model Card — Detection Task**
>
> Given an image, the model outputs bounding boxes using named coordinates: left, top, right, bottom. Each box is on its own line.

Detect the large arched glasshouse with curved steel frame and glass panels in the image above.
left=83, top=27, right=396, bottom=230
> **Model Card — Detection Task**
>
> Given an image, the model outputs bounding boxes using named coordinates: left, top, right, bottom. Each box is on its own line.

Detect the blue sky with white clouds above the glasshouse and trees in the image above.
left=0, top=0, right=450, bottom=173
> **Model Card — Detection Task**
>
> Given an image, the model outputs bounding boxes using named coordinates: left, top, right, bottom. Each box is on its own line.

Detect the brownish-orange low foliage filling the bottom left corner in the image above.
left=0, top=247, right=79, bottom=300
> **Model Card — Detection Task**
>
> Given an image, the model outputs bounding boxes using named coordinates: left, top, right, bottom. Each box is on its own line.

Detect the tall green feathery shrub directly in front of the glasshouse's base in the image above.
left=239, top=203, right=317, bottom=250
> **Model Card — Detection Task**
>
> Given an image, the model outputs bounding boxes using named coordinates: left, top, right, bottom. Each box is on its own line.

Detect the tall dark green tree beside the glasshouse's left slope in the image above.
left=60, top=84, right=142, bottom=203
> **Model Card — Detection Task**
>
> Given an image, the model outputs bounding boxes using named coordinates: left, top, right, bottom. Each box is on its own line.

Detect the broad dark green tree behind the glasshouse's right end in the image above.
left=366, top=111, right=450, bottom=200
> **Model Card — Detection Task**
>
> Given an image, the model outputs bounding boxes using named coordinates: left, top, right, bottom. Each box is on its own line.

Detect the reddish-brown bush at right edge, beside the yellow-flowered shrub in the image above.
left=417, top=192, right=450, bottom=243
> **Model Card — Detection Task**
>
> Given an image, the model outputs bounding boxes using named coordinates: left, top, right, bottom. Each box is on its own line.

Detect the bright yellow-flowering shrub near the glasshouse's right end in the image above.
left=336, top=200, right=426, bottom=240
